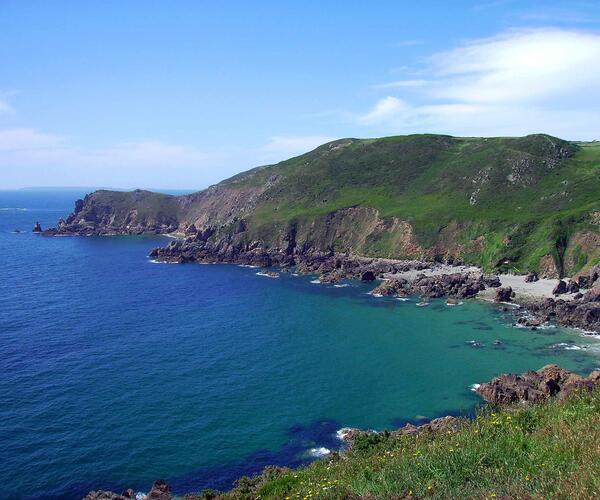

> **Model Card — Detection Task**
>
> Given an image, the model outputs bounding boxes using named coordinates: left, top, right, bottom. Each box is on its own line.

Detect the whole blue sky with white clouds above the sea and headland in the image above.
left=0, top=0, right=600, bottom=189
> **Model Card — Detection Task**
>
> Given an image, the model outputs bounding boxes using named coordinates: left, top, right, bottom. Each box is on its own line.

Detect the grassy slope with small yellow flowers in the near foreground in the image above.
left=203, top=389, right=600, bottom=499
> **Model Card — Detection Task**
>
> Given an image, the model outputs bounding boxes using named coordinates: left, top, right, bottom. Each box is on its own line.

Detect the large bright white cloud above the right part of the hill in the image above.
left=357, top=29, right=600, bottom=139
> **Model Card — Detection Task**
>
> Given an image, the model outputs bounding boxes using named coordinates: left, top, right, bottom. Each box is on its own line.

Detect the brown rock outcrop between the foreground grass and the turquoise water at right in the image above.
left=477, top=365, right=600, bottom=404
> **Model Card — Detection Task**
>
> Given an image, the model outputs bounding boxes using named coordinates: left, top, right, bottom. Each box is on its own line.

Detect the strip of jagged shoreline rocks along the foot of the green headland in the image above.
left=150, top=234, right=600, bottom=333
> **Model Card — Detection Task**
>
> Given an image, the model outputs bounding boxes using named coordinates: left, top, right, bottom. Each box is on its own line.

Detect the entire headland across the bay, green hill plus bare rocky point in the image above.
left=47, top=135, right=600, bottom=276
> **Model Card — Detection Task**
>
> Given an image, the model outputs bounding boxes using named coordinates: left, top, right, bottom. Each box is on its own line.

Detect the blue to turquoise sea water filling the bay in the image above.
left=0, top=192, right=600, bottom=498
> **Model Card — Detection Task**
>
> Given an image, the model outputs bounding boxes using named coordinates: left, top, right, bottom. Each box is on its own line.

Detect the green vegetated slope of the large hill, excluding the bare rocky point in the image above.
left=214, top=135, right=600, bottom=273
